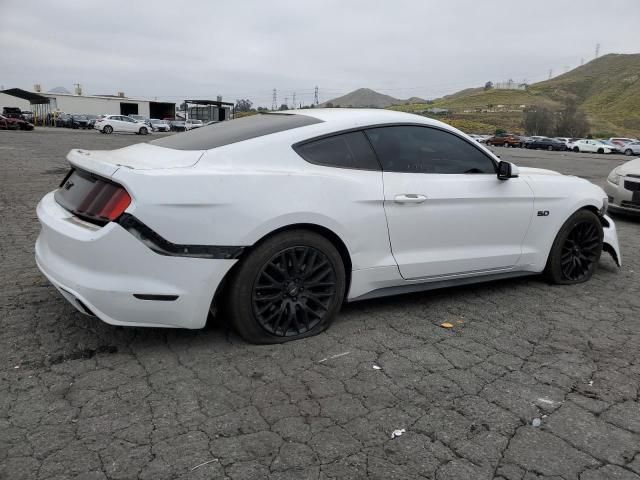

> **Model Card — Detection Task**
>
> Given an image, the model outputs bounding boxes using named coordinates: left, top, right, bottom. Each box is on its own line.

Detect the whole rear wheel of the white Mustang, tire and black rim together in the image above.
left=226, top=230, right=346, bottom=344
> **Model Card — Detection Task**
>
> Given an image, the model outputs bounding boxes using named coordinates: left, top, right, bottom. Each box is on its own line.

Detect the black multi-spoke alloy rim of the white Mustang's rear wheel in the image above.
left=252, top=246, right=336, bottom=337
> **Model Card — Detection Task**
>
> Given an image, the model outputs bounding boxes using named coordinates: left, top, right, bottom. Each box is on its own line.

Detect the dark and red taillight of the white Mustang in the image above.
left=55, top=169, right=131, bottom=225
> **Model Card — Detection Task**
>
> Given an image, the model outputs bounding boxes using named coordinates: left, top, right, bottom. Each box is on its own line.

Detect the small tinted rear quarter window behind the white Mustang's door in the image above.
left=294, top=132, right=380, bottom=170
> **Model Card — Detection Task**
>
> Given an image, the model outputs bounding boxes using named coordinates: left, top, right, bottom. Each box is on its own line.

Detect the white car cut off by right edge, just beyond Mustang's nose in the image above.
left=604, top=158, right=640, bottom=214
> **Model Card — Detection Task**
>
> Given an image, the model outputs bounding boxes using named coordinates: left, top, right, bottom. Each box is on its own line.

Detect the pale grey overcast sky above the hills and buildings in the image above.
left=0, top=0, right=640, bottom=106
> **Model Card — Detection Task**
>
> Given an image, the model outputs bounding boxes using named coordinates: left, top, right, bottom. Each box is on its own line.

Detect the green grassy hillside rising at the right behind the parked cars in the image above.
left=384, top=54, right=640, bottom=136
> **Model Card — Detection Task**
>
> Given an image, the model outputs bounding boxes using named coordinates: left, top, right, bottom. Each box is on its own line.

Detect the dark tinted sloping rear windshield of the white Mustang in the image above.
left=149, top=113, right=322, bottom=150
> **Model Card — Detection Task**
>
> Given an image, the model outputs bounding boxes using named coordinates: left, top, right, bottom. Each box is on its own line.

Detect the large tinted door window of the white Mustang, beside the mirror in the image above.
left=366, top=125, right=496, bottom=174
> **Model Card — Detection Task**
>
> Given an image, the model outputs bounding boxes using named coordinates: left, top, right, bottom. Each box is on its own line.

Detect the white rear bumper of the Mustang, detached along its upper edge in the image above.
left=36, top=192, right=236, bottom=328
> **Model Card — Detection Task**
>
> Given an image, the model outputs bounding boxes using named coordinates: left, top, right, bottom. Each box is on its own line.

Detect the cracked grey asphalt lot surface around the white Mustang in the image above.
left=0, top=129, right=640, bottom=480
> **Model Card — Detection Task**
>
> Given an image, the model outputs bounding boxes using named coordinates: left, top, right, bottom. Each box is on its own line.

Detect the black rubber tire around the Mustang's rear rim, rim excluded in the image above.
left=225, top=230, right=346, bottom=344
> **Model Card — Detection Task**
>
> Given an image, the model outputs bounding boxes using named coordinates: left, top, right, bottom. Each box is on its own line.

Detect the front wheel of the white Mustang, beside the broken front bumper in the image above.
left=544, top=210, right=604, bottom=285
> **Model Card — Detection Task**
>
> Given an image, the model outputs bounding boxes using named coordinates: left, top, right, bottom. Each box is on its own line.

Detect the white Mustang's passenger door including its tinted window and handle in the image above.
left=366, top=125, right=533, bottom=280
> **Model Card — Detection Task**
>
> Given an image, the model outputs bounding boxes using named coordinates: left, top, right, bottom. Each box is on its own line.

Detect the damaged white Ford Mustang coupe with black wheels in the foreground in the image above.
left=36, top=109, right=621, bottom=343
